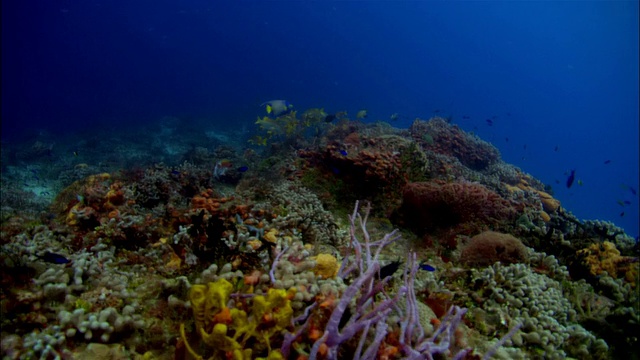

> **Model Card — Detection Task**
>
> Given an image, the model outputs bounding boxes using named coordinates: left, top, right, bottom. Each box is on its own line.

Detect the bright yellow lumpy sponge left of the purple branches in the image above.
left=180, top=279, right=295, bottom=360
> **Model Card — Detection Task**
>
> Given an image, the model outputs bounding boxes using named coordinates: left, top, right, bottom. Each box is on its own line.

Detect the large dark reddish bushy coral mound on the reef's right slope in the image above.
left=401, top=182, right=516, bottom=233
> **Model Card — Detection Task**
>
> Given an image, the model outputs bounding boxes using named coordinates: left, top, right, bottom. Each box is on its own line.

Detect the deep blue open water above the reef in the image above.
left=2, top=0, right=639, bottom=236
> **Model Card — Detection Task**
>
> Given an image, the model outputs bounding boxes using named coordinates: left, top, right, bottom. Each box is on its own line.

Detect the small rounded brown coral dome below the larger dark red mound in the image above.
left=460, top=231, right=527, bottom=266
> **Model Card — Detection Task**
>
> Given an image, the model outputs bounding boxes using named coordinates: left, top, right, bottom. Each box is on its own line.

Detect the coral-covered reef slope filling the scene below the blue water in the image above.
left=0, top=113, right=640, bottom=359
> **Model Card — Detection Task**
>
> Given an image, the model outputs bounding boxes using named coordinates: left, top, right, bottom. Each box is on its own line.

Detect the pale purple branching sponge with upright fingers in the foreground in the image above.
left=282, top=203, right=476, bottom=359
